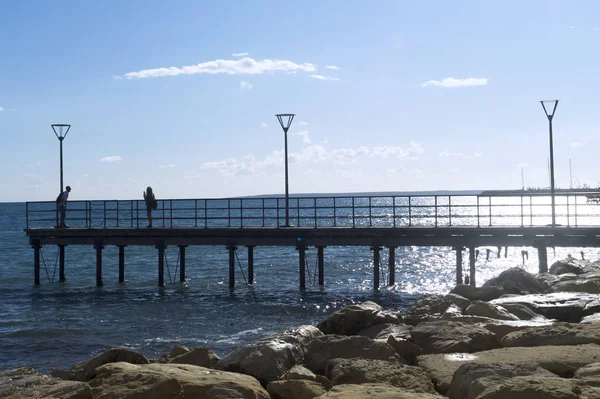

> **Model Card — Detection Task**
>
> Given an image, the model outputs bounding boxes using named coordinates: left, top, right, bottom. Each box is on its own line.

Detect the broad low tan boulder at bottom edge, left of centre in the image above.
left=89, top=362, right=270, bottom=399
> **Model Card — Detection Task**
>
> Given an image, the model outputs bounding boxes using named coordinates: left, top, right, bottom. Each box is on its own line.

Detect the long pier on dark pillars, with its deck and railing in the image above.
left=25, top=191, right=600, bottom=289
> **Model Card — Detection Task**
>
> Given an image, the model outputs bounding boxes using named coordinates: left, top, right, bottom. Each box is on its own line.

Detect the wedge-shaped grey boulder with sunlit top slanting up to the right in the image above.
left=215, top=326, right=323, bottom=386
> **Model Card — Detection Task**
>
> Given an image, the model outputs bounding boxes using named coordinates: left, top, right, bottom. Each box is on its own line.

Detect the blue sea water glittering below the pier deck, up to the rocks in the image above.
left=0, top=195, right=600, bottom=372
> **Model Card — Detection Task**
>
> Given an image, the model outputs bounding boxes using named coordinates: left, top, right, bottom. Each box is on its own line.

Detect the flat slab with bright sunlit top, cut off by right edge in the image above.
left=491, top=292, right=600, bottom=323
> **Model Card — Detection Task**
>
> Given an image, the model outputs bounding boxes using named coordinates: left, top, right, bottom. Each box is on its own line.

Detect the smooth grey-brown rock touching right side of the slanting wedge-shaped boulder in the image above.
left=304, top=335, right=399, bottom=374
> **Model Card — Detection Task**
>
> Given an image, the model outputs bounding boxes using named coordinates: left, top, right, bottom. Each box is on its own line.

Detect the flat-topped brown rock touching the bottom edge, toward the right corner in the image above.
left=447, top=363, right=556, bottom=399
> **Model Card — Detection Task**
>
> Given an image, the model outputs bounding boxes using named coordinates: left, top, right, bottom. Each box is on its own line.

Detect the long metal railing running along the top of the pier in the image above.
left=26, top=193, right=600, bottom=229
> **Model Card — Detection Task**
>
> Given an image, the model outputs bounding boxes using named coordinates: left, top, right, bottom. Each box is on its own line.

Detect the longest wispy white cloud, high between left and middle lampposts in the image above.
left=118, top=57, right=317, bottom=79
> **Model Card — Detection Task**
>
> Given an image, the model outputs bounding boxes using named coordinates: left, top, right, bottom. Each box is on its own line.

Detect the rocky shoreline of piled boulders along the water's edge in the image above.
left=0, top=258, right=600, bottom=399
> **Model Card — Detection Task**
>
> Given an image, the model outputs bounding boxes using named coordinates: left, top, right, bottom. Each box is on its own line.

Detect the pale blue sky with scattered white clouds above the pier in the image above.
left=0, top=0, right=600, bottom=201
